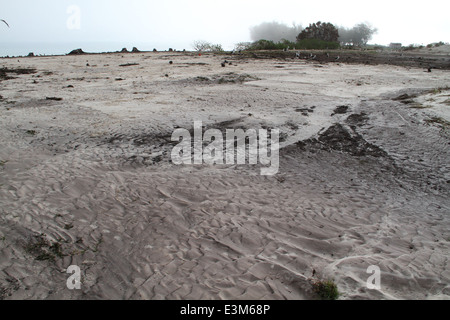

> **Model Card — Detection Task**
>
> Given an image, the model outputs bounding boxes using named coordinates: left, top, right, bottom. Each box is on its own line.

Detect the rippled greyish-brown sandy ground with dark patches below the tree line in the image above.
left=0, top=48, right=450, bottom=300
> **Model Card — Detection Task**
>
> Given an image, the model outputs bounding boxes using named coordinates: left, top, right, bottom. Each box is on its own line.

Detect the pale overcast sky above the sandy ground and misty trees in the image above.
left=0, top=0, right=450, bottom=49
